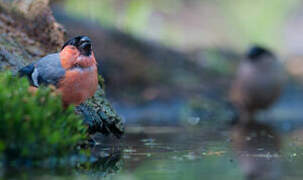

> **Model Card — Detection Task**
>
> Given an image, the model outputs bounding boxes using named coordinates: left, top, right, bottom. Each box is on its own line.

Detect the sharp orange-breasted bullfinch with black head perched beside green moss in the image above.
left=19, top=36, right=98, bottom=107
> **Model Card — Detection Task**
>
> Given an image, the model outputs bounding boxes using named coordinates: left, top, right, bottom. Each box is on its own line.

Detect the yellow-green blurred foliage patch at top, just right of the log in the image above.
left=66, top=0, right=151, bottom=33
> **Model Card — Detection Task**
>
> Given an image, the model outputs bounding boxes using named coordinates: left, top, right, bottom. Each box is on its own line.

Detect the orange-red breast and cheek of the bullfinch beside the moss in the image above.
left=58, top=45, right=98, bottom=107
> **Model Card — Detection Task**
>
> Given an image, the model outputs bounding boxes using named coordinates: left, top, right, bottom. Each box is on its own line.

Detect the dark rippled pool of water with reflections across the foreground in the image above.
left=1, top=123, right=303, bottom=180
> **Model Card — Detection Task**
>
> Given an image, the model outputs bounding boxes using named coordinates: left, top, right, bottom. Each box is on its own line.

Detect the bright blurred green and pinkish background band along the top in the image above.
left=65, top=0, right=300, bottom=50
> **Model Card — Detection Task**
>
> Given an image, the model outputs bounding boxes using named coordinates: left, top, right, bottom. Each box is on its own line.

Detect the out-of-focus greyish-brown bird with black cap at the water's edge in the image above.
left=230, top=46, right=285, bottom=123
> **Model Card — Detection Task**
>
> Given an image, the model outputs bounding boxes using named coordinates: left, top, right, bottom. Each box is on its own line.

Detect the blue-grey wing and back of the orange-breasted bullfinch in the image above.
left=19, top=54, right=65, bottom=87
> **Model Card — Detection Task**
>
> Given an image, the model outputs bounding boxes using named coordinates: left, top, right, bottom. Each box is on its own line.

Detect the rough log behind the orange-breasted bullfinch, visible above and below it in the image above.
left=0, top=0, right=124, bottom=137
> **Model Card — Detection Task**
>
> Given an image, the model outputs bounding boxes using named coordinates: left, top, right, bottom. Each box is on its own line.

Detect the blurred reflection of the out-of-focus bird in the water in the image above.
left=231, top=121, right=282, bottom=180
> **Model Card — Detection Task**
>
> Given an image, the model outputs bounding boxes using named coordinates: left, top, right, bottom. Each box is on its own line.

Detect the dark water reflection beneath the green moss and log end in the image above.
left=0, top=149, right=123, bottom=180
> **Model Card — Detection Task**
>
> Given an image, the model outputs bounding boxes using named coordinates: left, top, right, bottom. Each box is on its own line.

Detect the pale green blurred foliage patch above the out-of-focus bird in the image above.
left=219, top=0, right=300, bottom=48
